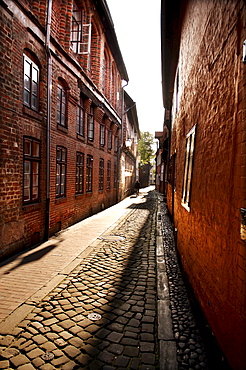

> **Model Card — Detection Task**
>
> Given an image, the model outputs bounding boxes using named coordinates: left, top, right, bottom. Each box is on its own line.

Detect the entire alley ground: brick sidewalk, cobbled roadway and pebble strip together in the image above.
left=0, top=188, right=211, bottom=370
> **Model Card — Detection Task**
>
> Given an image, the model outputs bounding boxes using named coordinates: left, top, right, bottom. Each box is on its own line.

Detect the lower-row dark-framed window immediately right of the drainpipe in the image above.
left=56, top=147, right=67, bottom=197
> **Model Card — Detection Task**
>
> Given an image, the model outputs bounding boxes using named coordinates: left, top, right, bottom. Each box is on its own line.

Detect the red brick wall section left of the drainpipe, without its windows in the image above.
left=0, top=3, right=45, bottom=257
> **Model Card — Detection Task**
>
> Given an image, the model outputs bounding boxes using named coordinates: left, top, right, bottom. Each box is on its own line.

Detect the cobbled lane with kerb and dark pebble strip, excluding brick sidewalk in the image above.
left=0, top=191, right=221, bottom=370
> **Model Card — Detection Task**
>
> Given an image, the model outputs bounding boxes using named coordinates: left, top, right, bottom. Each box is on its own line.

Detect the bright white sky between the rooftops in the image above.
left=107, top=0, right=164, bottom=135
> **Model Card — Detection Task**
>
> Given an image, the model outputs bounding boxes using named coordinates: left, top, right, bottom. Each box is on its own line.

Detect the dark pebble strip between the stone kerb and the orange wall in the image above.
left=161, top=203, right=208, bottom=370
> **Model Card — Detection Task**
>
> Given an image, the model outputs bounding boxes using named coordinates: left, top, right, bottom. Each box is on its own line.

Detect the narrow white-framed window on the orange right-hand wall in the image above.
left=182, top=125, right=196, bottom=211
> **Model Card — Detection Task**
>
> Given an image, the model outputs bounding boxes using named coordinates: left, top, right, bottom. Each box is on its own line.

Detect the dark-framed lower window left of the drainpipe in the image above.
left=23, top=138, right=40, bottom=203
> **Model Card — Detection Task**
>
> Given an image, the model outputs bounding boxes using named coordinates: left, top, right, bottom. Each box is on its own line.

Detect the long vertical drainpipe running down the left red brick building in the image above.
left=44, top=0, right=52, bottom=240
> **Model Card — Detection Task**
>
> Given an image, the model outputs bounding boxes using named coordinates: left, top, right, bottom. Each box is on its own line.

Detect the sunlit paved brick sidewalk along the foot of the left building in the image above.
left=0, top=187, right=153, bottom=330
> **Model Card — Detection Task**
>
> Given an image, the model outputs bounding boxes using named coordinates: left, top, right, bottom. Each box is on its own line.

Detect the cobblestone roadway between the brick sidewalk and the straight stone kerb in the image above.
left=0, top=192, right=158, bottom=370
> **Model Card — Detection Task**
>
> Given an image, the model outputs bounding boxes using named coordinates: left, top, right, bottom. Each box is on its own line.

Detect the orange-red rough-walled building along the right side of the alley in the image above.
left=162, top=0, right=246, bottom=370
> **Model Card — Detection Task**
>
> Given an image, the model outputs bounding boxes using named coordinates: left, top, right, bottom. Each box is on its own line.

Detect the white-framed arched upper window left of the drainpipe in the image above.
left=23, top=54, right=39, bottom=111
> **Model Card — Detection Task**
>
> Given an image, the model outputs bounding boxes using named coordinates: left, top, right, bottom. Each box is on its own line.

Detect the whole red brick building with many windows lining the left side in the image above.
left=0, top=0, right=138, bottom=257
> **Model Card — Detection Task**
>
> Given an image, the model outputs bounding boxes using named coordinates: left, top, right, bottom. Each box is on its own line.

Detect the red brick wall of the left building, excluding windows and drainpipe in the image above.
left=0, top=0, right=125, bottom=257
